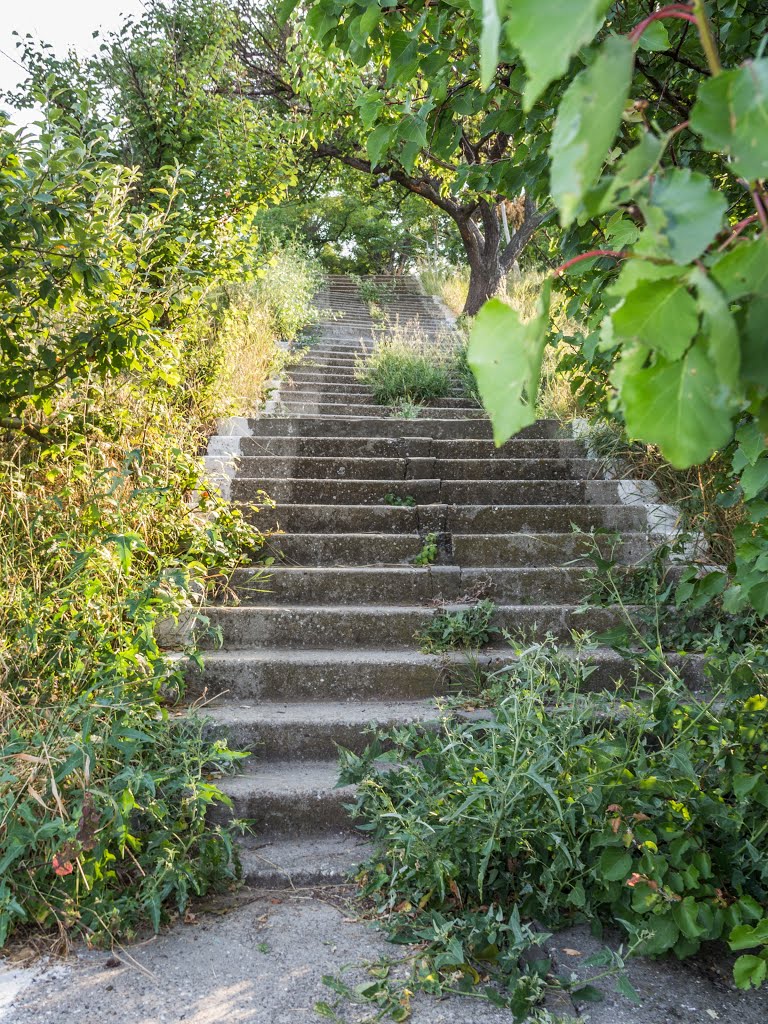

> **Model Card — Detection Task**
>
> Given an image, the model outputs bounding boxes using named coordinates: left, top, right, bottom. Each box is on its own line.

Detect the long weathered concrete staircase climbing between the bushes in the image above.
left=189, top=276, right=663, bottom=886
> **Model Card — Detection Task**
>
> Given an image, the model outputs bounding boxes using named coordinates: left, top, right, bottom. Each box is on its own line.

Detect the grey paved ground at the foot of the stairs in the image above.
left=6, top=890, right=768, bottom=1024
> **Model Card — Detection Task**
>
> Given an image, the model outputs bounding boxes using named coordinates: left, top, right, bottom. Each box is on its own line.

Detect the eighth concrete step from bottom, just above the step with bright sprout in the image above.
left=249, top=499, right=648, bottom=534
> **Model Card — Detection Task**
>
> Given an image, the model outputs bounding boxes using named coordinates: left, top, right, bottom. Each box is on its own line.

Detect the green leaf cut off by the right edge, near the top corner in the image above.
left=690, top=59, right=768, bottom=181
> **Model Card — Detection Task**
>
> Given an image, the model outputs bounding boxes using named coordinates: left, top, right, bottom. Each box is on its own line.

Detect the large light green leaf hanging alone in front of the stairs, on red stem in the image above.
left=467, top=282, right=550, bottom=445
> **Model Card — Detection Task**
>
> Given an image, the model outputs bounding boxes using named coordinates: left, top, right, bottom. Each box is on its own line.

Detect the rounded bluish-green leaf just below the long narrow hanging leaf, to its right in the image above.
left=637, top=168, right=727, bottom=263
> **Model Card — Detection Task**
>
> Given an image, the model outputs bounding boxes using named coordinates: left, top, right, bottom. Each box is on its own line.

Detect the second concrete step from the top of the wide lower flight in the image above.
left=238, top=436, right=594, bottom=458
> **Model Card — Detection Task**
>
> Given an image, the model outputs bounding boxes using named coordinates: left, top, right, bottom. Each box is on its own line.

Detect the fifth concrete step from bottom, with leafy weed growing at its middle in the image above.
left=200, top=604, right=622, bottom=648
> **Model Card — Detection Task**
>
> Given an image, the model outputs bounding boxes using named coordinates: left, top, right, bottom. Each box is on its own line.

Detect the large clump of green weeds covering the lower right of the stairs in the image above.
left=341, top=639, right=768, bottom=1007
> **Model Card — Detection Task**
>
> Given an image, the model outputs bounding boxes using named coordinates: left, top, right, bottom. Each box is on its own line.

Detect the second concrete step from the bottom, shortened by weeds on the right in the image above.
left=212, top=760, right=354, bottom=839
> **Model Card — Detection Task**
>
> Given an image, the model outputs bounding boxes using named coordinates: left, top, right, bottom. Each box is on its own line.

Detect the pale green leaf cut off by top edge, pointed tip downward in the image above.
left=507, top=0, right=611, bottom=111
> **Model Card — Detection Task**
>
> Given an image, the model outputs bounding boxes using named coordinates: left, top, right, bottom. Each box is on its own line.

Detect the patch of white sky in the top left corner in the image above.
left=0, top=0, right=143, bottom=100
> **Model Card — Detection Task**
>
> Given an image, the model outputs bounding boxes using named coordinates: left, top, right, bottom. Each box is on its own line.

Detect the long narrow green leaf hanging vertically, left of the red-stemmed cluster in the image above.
left=550, top=36, right=634, bottom=227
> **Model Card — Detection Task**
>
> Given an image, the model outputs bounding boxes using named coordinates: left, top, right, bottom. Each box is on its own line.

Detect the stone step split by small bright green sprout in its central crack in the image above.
left=267, top=528, right=648, bottom=567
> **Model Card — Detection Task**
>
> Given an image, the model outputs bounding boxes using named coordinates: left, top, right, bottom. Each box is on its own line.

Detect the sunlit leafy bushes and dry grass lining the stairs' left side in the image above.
left=0, top=101, right=313, bottom=945
